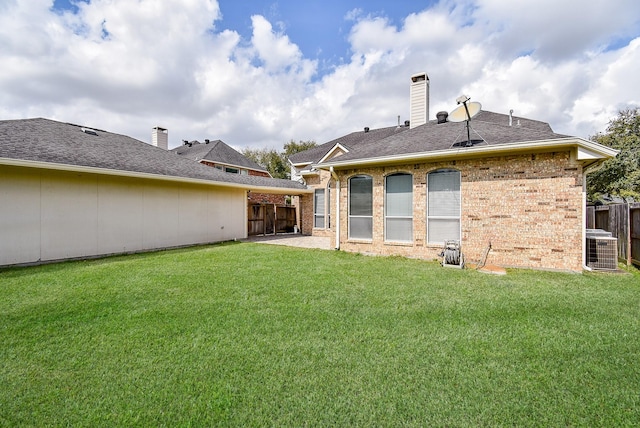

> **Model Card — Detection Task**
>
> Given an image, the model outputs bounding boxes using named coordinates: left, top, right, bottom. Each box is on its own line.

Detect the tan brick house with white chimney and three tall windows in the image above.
left=289, top=73, right=617, bottom=271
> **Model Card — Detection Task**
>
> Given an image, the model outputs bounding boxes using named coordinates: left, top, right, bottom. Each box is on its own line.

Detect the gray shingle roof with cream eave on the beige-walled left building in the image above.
left=0, top=118, right=308, bottom=194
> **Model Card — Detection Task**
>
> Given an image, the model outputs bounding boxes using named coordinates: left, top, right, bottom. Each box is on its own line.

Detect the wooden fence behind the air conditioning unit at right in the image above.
left=587, top=202, right=640, bottom=265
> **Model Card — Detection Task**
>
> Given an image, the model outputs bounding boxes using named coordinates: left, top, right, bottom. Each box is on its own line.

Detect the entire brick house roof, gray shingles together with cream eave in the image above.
left=291, top=110, right=617, bottom=169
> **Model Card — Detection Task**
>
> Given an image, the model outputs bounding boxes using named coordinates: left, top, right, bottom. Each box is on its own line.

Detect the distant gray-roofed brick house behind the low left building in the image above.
left=174, top=137, right=286, bottom=206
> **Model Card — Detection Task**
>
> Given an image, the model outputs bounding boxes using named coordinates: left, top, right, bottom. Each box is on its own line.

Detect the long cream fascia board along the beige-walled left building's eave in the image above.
left=0, top=158, right=313, bottom=195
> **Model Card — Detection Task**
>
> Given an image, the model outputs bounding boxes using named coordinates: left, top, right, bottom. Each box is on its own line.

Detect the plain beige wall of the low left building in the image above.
left=0, top=166, right=247, bottom=265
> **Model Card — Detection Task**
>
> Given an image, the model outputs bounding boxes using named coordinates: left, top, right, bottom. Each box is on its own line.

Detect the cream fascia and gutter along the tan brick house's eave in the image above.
left=314, top=138, right=619, bottom=169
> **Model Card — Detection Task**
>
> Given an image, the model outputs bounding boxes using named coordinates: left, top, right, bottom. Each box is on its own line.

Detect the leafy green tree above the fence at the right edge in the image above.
left=587, top=107, right=640, bottom=202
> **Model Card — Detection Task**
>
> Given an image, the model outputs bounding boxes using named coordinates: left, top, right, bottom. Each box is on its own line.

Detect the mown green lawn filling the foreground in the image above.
left=0, top=243, right=640, bottom=427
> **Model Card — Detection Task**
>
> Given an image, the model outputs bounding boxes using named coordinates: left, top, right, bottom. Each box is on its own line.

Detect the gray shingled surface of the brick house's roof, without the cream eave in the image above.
left=290, top=111, right=570, bottom=164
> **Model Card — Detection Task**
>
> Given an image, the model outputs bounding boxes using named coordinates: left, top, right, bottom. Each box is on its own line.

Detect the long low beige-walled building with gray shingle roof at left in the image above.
left=0, top=119, right=309, bottom=266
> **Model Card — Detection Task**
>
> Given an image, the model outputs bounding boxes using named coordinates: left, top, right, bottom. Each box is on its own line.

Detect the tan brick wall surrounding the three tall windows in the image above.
left=302, top=151, right=584, bottom=271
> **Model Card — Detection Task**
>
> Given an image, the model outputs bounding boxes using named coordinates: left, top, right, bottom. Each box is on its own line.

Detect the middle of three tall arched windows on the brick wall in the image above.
left=384, top=174, right=413, bottom=242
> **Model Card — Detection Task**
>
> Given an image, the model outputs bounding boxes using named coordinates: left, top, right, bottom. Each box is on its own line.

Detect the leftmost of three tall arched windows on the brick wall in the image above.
left=349, top=175, right=373, bottom=239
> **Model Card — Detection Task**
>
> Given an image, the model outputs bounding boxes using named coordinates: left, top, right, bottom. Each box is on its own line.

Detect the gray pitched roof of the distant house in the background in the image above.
left=170, top=140, right=269, bottom=173
